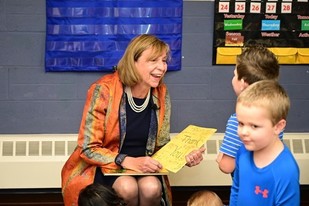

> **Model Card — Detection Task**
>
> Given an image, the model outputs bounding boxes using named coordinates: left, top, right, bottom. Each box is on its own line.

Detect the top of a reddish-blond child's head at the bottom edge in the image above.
left=187, top=190, right=223, bottom=206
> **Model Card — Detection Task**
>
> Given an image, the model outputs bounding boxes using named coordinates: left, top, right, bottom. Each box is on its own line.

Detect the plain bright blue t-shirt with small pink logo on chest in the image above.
left=229, top=145, right=300, bottom=206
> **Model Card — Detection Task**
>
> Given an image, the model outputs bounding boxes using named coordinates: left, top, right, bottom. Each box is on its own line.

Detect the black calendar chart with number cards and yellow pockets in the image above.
left=213, top=0, right=309, bottom=65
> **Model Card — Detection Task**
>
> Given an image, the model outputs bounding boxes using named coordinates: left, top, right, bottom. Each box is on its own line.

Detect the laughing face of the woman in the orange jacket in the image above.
left=135, top=48, right=167, bottom=87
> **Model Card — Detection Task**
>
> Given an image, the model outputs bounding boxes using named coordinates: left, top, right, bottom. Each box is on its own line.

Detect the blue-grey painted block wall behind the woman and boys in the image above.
left=0, top=0, right=309, bottom=134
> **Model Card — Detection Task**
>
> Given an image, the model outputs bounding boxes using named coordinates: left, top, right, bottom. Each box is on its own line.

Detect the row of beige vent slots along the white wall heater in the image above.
left=0, top=134, right=309, bottom=157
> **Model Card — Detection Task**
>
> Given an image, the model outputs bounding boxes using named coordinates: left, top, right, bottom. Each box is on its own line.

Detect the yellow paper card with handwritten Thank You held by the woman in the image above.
left=152, top=125, right=217, bottom=173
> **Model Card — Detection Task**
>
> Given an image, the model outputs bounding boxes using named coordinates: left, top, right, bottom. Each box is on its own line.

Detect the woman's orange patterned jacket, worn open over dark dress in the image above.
left=61, top=72, right=172, bottom=206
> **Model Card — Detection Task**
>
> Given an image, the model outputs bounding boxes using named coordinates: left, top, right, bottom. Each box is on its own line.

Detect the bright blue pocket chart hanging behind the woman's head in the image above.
left=45, top=0, right=183, bottom=72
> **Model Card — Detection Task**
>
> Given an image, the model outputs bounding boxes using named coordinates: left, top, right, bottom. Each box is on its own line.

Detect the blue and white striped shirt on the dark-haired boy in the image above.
left=220, top=113, right=283, bottom=158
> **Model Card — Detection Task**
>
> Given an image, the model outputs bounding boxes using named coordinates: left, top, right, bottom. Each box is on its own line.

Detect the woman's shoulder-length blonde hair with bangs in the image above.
left=117, top=34, right=170, bottom=86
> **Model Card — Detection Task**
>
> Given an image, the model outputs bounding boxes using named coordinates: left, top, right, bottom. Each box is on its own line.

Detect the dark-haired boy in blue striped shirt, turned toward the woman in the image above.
left=217, top=46, right=283, bottom=174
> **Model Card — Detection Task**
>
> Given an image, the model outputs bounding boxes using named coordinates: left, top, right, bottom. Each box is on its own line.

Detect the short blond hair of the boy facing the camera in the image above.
left=237, top=80, right=290, bottom=125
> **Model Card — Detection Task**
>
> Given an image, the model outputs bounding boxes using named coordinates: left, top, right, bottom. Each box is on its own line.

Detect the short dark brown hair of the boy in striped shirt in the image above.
left=236, top=45, right=280, bottom=85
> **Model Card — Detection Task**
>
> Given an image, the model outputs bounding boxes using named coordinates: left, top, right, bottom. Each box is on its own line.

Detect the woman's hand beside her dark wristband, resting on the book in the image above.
left=122, top=156, right=162, bottom=173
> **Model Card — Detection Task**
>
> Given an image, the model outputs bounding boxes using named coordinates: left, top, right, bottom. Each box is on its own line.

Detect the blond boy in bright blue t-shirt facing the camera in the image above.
left=230, top=80, right=300, bottom=206
